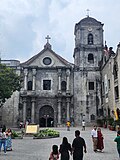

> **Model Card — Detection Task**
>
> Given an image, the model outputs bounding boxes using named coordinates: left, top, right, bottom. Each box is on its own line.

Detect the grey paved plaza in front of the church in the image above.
left=0, top=127, right=118, bottom=160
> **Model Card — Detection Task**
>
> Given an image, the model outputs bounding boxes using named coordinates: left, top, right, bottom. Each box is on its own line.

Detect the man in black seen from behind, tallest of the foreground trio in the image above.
left=72, top=130, right=87, bottom=160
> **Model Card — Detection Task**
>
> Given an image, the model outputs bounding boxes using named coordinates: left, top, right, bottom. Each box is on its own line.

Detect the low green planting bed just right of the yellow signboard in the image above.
left=34, top=128, right=60, bottom=138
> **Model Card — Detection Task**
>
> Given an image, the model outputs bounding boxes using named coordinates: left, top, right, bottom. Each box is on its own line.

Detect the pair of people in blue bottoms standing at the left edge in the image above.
left=0, top=125, right=12, bottom=153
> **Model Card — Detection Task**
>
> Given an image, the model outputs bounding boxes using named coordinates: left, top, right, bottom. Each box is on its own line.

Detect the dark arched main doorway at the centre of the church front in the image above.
left=39, top=105, right=54, bottom=127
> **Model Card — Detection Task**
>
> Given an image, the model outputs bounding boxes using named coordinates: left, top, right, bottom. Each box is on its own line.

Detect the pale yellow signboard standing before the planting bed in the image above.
left=26, top=125, right=39, bottom=133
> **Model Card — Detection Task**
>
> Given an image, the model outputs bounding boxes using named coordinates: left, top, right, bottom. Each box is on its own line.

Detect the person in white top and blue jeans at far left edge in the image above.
left=0, top=129, right=6, bottom=153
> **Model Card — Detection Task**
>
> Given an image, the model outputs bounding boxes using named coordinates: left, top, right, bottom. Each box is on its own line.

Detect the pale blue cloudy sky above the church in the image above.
left=0, top=0, right=120, bottom=62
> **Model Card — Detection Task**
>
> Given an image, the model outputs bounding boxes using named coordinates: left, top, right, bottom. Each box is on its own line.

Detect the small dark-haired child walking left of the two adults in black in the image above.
left=49, top=145, right=59, bottom=160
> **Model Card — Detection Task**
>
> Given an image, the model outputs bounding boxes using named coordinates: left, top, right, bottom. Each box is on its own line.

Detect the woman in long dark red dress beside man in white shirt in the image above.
left=97, top=128, right=104, bottom=152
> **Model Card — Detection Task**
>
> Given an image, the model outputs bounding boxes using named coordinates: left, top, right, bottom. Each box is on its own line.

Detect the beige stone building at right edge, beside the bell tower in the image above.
left=101, top=44, right=120, bottom=119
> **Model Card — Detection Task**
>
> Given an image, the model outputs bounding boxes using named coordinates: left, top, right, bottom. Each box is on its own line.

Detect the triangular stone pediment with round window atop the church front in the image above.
left=21, top=44, right=73, bottom=68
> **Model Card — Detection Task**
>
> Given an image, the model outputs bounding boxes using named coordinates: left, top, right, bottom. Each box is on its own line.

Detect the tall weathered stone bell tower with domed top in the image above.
left=73, top=16, right=103, bottom=125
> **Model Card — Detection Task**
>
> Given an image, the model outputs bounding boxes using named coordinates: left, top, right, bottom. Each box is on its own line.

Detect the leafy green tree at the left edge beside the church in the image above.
left=0, top=64, right=20, bottom=102
